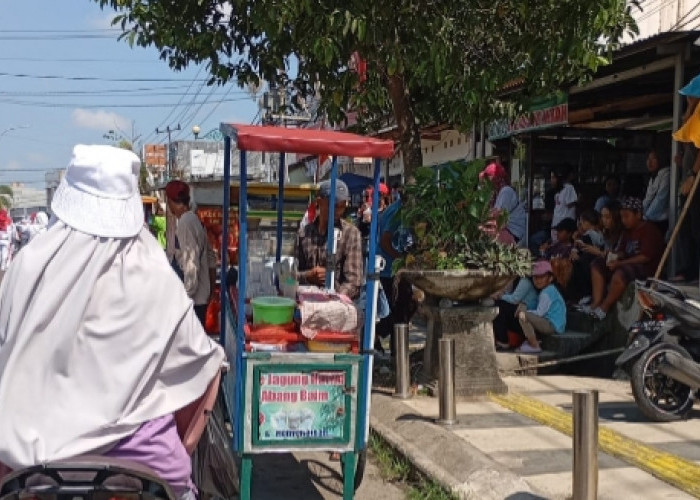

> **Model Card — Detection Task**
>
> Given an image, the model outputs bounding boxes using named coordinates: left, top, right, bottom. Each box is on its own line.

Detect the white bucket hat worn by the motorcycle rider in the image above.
left=51, top=144, right=144, bottom=238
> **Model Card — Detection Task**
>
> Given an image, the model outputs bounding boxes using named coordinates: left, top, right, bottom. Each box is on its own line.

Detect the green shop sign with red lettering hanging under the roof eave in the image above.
left=488, top=93, right=569, bottom=141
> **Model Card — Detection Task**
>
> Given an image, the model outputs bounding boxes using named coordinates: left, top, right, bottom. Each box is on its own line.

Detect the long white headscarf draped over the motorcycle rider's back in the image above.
left=0, top=144, right=224, bottom=468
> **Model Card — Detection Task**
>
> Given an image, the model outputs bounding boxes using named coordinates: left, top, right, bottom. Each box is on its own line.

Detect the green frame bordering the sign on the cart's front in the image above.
left=251, top=363, right=357, bottom=449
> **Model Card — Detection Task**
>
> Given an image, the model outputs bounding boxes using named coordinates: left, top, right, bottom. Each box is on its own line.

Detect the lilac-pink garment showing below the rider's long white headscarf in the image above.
left=104, top=415, right=194, bottom=496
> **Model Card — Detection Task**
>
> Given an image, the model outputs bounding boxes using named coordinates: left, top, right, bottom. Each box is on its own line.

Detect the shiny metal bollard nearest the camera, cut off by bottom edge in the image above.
left=573, top=390, right=598, bottom=500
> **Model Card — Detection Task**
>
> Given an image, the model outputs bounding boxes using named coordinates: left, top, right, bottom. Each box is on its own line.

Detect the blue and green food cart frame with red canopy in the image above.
left=220, top=123, right=394, bottom=500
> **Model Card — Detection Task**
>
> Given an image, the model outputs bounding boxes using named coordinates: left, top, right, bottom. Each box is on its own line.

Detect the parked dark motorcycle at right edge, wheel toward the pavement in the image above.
left=615, top=279, right=700, bottom=422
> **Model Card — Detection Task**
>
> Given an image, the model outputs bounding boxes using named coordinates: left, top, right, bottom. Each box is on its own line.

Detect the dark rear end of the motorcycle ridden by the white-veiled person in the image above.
left=0, top=456, right=175, bottom=500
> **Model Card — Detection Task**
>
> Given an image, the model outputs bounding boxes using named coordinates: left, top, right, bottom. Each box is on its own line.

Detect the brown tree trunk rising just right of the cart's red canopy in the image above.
left=387, top=74, right=423, bottom=180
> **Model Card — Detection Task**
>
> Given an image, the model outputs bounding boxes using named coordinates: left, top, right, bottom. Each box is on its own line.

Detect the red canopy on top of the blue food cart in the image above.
left=221, top=123, right=394, bottom=158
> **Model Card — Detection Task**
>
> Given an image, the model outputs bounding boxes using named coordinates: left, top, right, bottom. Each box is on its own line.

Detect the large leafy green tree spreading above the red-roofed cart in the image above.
left=95, top=0, right=636, bottom=179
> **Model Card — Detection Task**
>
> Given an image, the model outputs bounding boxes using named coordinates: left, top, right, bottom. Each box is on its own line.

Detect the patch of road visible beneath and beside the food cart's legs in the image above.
left=251, top=453, right=406, bottom=500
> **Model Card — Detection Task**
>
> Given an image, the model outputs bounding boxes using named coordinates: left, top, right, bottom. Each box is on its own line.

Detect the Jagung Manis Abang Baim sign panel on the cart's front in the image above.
left=256, top=370, right=349, bottom=444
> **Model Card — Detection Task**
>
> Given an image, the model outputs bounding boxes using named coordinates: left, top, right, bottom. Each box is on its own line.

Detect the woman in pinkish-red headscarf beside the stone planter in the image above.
left=479, top=161, right=527, bottom=244
